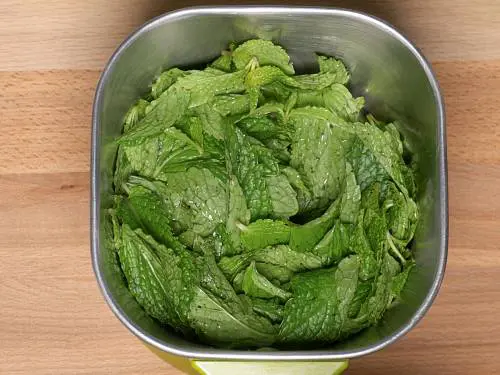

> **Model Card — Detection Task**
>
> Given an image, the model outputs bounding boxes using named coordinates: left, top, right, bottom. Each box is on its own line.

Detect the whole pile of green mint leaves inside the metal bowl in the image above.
left=109, top=40, right=418, bottom=348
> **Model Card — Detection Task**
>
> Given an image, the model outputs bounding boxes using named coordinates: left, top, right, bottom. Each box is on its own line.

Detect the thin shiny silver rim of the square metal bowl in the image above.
left=90, top=6, right=448, bottom=361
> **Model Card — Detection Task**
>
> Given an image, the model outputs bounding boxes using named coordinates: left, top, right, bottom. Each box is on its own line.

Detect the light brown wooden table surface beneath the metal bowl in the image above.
left=0, top=0, right=500, bottom=375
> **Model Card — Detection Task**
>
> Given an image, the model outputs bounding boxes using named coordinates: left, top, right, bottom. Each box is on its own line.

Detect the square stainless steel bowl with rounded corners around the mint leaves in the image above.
left=91, top=7, right=448, bottom=361
